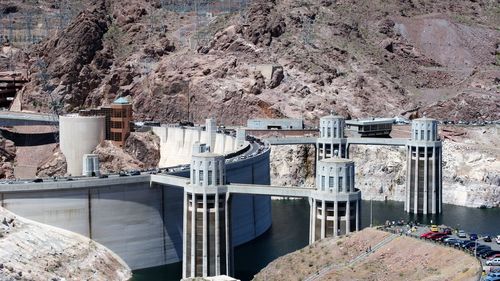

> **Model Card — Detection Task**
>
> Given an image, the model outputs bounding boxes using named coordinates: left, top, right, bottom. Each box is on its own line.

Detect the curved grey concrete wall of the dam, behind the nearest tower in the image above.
left=0, top=130, right=271, bottom=269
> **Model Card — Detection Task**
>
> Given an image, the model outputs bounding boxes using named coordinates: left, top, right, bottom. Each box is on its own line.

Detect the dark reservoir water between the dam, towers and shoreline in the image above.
left=132, top=200, right=500, bottom=281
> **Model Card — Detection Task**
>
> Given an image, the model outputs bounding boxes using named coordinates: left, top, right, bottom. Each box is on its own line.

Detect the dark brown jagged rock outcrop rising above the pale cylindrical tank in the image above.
left=22, top=0, right=110, bottom=111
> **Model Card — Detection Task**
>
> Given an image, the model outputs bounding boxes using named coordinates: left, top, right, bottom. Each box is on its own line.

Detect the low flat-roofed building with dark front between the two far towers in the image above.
left=345, top=118, right=394, bottom=137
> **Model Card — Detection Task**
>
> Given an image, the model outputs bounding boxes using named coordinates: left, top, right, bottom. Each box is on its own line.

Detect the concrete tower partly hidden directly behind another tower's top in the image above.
left=316, top=113, right=349, bottom=161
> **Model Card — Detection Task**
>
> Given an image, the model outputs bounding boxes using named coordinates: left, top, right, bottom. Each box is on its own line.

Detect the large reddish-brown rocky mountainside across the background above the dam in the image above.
left=6, top=0, right=500, bottom=124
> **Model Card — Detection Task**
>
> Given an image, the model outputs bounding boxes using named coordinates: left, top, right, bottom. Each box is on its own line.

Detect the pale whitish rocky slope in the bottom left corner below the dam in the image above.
left=0, top=207, right=132, bottom=281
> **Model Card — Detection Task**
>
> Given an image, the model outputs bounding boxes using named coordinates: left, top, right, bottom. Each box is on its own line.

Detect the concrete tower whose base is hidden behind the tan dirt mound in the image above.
left=309, top=157, right=361, bottom=243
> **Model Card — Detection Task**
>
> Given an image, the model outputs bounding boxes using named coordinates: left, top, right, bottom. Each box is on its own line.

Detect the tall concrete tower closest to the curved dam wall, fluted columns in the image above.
left=182, top=152, right=232, bottom=278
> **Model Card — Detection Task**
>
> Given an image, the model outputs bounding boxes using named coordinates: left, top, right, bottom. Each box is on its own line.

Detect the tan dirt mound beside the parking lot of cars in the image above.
left=253, top=228, right=481, bottom=281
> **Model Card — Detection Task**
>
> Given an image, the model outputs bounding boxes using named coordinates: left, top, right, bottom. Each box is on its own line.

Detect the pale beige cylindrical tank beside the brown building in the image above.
left=59, top=115, right=105, bottom=175
